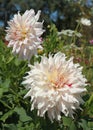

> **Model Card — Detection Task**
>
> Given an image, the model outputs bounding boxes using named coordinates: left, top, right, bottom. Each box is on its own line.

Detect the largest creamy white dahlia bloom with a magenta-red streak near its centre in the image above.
left=22, top=52, right=86, bottom=121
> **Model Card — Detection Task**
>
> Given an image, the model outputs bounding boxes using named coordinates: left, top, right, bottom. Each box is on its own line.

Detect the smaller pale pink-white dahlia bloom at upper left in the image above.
left=5, top=9, right=44, bottom=60
